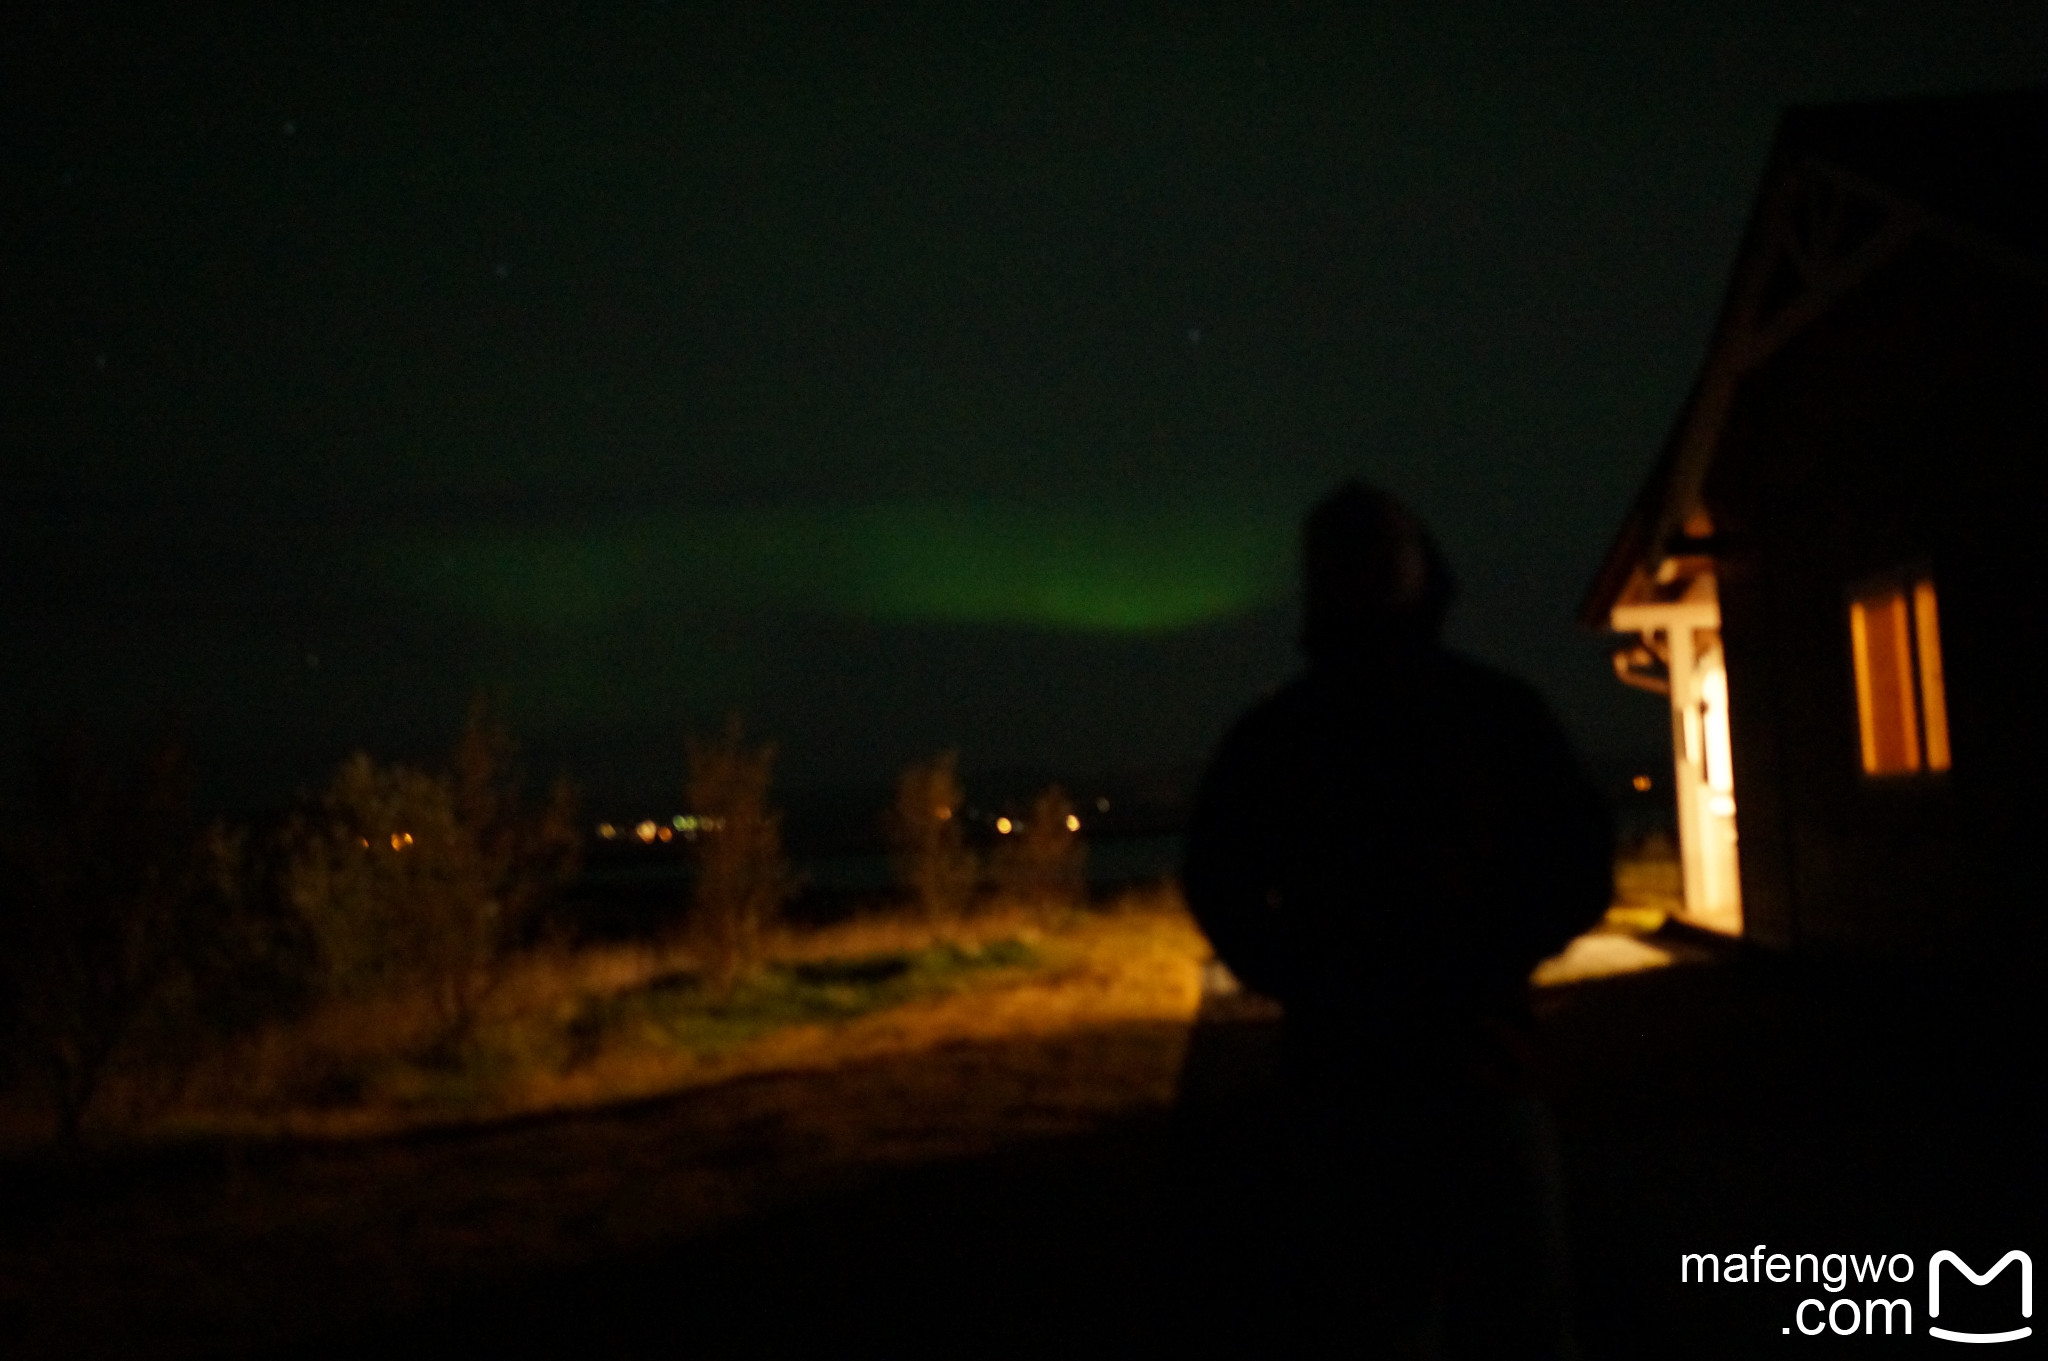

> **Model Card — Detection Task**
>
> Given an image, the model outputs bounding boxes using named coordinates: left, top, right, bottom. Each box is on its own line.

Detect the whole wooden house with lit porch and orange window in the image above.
left=1583, top=90, right=2048, bottom=954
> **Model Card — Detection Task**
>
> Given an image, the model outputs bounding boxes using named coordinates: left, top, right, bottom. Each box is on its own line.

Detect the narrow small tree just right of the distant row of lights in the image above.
left=688, top=716, right=793, bottom=991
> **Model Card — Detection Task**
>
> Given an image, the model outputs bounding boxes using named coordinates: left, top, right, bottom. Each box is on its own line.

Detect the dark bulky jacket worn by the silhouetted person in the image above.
left=1182, top=643, right=1614, bottom=1072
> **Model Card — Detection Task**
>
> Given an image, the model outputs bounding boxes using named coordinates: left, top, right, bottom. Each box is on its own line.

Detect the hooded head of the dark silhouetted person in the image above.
left=1300, top=481, right=1456, bottom=665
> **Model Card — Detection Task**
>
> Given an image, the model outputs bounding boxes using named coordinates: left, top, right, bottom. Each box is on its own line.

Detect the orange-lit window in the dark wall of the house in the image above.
left=1849, top=577, right=1948, bottom=776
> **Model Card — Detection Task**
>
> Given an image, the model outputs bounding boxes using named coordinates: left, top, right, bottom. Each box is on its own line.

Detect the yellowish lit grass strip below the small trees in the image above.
left=0, top=888, right=1208, bottom=1150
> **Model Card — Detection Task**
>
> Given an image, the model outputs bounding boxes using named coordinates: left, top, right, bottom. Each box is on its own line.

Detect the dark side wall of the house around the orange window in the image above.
left=1704, top=237, right=2048, bottom=950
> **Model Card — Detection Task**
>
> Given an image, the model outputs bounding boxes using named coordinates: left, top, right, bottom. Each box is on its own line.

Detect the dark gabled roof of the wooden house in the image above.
left=1579, top=86, right=2048, bottom=628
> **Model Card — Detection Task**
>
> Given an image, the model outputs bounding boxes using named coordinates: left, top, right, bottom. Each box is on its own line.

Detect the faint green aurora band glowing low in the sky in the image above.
left=379, top=501, right=1292, bottom=636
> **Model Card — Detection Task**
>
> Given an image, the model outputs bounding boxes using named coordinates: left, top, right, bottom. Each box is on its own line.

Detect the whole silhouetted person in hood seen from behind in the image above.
left=1184, top=483, right=1612, bottom=1357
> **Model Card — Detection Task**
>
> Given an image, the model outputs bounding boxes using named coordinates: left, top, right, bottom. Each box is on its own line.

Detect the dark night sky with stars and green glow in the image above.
left=0, top=0, right=2048, bottom=806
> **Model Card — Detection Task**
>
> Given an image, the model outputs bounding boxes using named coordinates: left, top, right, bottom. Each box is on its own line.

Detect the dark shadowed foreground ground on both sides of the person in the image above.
left=0, top=916, right=2048, bottom=1359
